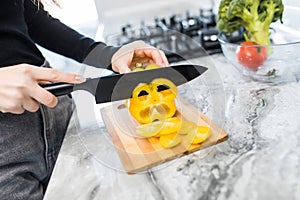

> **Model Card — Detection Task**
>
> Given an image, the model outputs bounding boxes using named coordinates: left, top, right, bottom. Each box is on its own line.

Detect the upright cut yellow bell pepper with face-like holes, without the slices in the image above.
left=127, top=78, right=178, bottom=123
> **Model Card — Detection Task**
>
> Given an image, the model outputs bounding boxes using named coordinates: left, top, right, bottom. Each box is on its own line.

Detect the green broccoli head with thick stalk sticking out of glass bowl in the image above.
left=217, top=0, right=284, bottom=45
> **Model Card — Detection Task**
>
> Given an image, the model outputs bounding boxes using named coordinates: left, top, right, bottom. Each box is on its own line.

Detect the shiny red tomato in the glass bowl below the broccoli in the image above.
left=236, top=41, right=268, bottom=70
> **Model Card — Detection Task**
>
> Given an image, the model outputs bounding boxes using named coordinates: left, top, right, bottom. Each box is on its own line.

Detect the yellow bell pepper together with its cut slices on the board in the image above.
left=127, top=78, right=211, bottom=148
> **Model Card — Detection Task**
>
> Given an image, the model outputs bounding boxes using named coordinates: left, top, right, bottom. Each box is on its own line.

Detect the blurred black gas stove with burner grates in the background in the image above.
left=106, top=9, right=221, bottom=63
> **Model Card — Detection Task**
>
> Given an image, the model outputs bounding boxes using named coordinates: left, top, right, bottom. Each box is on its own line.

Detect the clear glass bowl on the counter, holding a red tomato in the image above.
left=218, top=30, right=300, bottom=83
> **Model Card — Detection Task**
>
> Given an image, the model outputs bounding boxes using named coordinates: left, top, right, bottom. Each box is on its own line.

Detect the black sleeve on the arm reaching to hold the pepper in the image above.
left=24, top=0, right=119, bottom=68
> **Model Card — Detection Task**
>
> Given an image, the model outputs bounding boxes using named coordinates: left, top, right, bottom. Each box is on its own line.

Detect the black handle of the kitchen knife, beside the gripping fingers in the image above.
left=41, top=83, right=74, bottom=96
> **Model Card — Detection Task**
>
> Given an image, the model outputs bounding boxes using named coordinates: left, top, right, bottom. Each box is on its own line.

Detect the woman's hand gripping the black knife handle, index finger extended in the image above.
left=0, top=64, right=84, bottom=114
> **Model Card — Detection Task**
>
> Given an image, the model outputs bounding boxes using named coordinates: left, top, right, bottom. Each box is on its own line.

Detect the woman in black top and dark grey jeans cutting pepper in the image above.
left=0, top=0, right=168, bottom=200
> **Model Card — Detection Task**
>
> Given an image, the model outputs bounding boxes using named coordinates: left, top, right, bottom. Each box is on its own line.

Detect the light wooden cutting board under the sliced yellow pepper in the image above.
left=101, top=98, right=228, bottom=174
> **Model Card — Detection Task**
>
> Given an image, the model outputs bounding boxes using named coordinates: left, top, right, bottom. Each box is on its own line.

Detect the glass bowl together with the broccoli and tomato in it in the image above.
left=217, top=0, right=300, bottom=83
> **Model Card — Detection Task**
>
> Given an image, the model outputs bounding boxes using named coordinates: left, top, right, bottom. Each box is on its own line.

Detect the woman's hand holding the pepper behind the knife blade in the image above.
left=111, top=41, right=169, bottom=73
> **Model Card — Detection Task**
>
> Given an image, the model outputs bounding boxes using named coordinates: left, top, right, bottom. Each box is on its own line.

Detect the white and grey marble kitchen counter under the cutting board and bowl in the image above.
left=45, top=54, right=300, bottom=200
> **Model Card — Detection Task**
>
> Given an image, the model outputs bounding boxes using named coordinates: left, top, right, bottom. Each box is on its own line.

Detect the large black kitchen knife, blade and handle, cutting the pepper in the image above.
left=41, top=64, right=207, bottom=103
